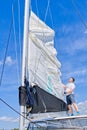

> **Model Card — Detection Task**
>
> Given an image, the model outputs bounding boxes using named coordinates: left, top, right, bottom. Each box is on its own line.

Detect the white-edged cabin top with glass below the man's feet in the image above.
left=26, top=112, right=87, bottom=130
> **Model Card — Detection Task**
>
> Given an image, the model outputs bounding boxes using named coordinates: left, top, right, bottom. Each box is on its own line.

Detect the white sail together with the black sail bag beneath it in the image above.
left=24, top=12, right=66, bottom=113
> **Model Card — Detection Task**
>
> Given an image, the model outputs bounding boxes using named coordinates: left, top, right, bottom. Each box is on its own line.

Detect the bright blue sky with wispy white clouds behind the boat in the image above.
left=0, top=0, right=87, bottom=128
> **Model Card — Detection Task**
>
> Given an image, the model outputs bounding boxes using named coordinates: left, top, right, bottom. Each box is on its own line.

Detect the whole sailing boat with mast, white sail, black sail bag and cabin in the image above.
left=19, top=0, right=87, bottom=130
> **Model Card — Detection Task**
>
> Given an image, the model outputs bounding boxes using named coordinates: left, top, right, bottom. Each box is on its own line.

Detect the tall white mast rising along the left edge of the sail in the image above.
left=19, top=0, right=30, bottom=130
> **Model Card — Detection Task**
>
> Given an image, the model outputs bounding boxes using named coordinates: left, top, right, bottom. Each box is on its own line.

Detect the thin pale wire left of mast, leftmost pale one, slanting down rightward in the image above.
left=12, top=5, right=20, bottom=83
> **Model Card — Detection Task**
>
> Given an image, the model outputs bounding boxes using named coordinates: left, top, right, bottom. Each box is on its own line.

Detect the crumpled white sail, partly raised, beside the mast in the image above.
left=28, top=12, right=64, bottom=99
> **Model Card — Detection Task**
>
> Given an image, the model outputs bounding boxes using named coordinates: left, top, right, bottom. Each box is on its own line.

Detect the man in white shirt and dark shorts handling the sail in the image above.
left=65, top=77, right=80, bottom=116
